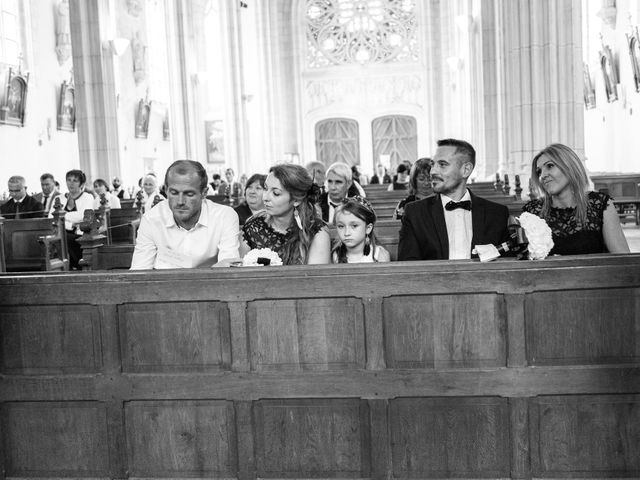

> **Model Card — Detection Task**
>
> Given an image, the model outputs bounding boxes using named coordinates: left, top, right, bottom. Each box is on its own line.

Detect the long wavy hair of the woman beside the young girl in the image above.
left=269, top=163, right=323, bottom=265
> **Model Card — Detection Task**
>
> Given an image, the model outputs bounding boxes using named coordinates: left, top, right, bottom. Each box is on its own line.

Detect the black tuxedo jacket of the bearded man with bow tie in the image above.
left=398, top=193, right=509, bottom=260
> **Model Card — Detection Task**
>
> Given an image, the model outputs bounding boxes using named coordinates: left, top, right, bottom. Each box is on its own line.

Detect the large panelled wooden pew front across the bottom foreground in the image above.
left=0, top=255, right=640, bottom=479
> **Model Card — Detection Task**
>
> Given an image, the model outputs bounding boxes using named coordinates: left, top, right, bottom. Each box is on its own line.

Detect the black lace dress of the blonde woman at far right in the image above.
left=522, top=192, right=611, bottom=255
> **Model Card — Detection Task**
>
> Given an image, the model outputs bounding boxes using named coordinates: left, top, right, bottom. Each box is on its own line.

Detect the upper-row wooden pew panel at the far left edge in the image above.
left=0, top=305, right=102, bottom=374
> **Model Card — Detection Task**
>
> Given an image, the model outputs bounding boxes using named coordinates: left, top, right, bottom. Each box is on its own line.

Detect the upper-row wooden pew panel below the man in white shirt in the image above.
left=119, top=302, right=231, bottom=372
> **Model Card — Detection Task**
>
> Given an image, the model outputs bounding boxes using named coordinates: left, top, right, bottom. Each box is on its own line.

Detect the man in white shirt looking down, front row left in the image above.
left=131, top=160, right=239, bottom=270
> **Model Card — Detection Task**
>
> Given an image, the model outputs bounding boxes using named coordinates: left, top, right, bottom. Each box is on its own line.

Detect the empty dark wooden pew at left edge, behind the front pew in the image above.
left=0, top=215, right=69, bottom=272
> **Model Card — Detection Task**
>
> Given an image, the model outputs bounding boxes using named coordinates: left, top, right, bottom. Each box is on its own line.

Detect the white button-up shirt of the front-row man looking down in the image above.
left=131, top=200, right=240, bottom=270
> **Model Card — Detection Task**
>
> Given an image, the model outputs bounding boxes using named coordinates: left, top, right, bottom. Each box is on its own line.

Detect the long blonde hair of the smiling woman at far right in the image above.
left=531, top=143, right=589, bottom=225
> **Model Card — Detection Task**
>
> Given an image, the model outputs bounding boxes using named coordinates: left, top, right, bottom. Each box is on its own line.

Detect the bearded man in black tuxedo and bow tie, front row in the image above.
left=398, top=138, right=509, bottom=260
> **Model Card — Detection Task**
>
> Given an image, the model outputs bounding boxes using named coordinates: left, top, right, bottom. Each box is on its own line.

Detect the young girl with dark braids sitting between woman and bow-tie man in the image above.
left=332, top=196, right=391, bottom=263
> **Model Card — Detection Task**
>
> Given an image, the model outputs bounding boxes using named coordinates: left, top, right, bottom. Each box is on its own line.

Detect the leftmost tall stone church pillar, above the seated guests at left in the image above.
left=69, top=0, right=120, bottom=181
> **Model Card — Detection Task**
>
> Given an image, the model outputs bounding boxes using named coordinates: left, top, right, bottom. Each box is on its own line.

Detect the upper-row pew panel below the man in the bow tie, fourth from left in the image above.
left=384, top=294, right=506, bottom=368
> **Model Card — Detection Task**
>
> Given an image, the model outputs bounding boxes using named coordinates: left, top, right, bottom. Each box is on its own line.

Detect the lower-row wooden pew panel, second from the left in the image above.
left=125, top=401, right=238, bottom=478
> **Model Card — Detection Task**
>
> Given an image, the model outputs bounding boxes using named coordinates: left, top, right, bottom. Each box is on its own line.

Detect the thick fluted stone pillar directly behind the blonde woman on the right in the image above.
left=496, top=0, right=584, bottom=188
